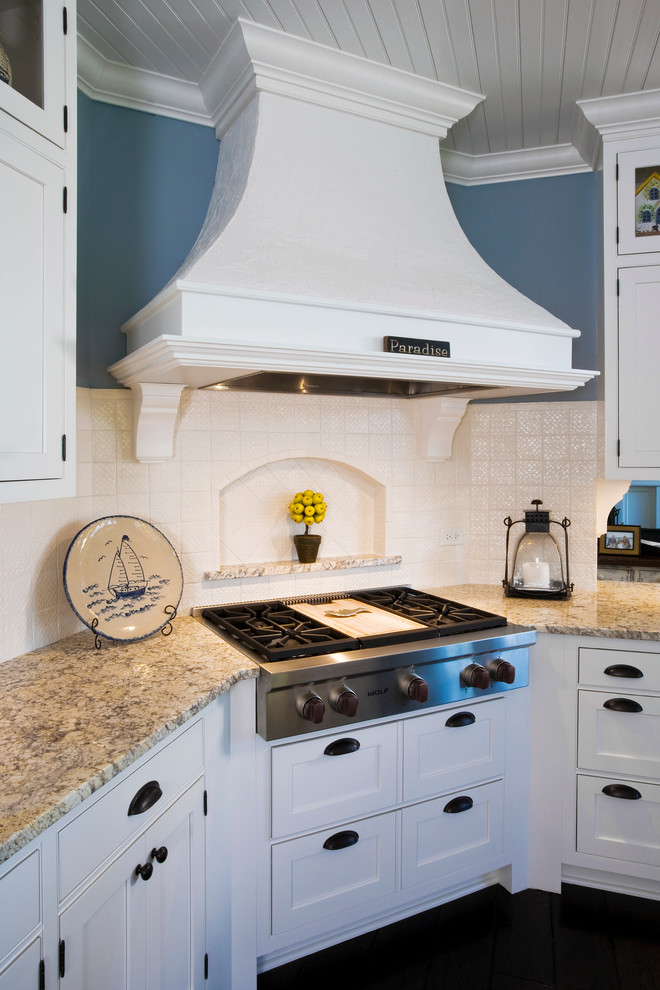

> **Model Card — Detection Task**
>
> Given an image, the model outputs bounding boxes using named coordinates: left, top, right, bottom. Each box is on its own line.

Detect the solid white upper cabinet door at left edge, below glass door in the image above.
left=0, top=122, right=65, bottom=482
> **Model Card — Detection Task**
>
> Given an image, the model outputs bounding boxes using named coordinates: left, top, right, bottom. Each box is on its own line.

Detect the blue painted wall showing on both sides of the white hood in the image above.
left=78, top=94, right=599, bottom=399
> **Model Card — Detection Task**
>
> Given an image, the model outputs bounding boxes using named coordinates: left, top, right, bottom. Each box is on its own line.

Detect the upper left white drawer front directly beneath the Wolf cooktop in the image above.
left=271, top=723, right=397, bottom=837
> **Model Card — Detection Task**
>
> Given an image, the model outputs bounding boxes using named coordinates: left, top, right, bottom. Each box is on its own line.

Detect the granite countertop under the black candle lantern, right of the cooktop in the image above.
left=433, top=581, right=660, bottom=641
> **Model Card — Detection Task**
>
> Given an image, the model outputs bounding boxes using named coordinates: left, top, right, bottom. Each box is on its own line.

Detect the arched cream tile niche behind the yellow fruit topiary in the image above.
left=216, top=456, right=386, bottom=567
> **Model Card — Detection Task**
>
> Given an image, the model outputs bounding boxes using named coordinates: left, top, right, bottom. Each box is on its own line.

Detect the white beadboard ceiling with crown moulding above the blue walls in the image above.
left=78, top=0, right=660, bottom=184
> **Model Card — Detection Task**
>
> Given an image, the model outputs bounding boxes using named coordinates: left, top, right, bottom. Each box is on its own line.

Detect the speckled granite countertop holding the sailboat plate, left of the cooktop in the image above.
left=0, top=617, right=259, bottom=863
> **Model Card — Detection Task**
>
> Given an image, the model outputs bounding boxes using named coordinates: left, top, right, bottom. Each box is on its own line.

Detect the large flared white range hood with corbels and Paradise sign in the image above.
left=110, top=20, right=595, bottom=461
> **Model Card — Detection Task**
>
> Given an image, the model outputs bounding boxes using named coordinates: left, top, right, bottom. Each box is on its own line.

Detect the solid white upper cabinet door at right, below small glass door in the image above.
left=618, top=265, right=660, bottom=472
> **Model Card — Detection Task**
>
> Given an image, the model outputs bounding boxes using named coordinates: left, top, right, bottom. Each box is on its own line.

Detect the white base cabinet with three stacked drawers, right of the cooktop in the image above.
left=530, top=635, right=660, bottom=899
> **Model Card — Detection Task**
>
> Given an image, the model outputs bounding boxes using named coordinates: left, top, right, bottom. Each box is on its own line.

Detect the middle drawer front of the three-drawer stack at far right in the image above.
left=578, top=691, right=660, bottom=777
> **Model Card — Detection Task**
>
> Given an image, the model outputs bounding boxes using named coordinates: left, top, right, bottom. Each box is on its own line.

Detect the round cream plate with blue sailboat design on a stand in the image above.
left=64, top=516, right=183, bottom=642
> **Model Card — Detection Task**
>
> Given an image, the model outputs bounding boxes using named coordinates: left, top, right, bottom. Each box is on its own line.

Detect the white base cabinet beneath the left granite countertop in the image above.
left=0, top=680, right=256, bottom=990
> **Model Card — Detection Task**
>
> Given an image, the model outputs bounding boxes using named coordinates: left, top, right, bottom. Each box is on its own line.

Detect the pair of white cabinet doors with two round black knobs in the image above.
left=60, top=780, right=204, bottom=990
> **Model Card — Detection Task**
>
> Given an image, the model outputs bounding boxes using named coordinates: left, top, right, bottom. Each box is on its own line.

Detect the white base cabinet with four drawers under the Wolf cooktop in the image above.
left=257, top=689, right=528, bottom=968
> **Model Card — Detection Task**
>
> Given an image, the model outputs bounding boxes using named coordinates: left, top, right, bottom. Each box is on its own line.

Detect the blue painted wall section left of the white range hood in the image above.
left=78, top=93, right=219, bottom=388
